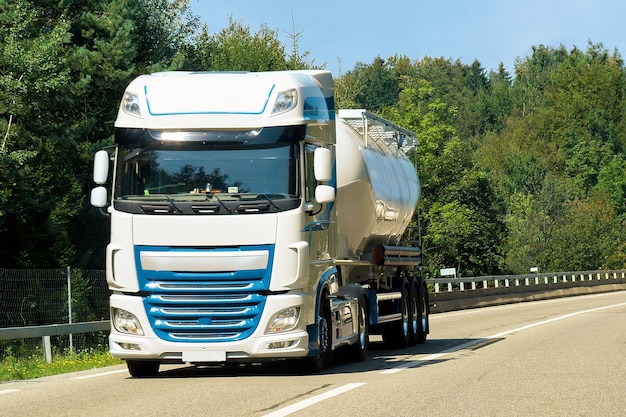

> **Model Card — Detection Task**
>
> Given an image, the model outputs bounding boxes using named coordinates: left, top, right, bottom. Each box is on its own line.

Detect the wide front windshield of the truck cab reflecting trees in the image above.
left=115, top=142, right=299, bottom=203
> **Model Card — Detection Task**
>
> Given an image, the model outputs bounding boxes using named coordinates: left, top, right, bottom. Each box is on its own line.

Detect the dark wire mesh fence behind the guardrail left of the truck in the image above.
left=0, top=268, right=110, bottom=360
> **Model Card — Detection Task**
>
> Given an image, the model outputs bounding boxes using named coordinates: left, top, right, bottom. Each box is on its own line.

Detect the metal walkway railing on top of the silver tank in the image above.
left=339, top=109, right=417, bottom=153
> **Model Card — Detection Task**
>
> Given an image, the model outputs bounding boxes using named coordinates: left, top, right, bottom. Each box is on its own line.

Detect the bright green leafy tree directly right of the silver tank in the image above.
left=385, top=79, right=505, bottom=276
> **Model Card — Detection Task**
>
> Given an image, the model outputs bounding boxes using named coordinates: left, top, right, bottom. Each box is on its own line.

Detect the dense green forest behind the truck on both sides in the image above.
left=0, top=0, right=626, bottom=277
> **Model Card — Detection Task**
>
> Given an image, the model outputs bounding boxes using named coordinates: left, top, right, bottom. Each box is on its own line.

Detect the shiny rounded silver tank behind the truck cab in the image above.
left=335, top=112, right=420, bottom=258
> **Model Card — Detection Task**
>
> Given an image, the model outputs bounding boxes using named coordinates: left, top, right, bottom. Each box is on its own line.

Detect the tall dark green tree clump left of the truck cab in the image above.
left=0, top=0, right=193, bottom=268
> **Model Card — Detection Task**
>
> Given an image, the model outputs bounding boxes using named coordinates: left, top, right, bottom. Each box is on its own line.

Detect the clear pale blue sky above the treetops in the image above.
left=190, top=0, right=626, bottom=76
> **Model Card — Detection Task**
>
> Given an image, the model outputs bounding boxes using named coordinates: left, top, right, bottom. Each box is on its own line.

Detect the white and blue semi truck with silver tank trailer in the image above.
left=91, top=71, right=429, bottom=377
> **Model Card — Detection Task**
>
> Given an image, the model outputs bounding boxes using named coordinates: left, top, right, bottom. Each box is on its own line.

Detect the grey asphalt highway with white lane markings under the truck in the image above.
left=0, top=292, right=626, bottom=417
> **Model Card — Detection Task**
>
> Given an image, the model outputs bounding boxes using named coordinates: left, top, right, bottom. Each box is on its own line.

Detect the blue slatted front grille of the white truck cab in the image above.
left=135, top=245, right=274, bottom=343
